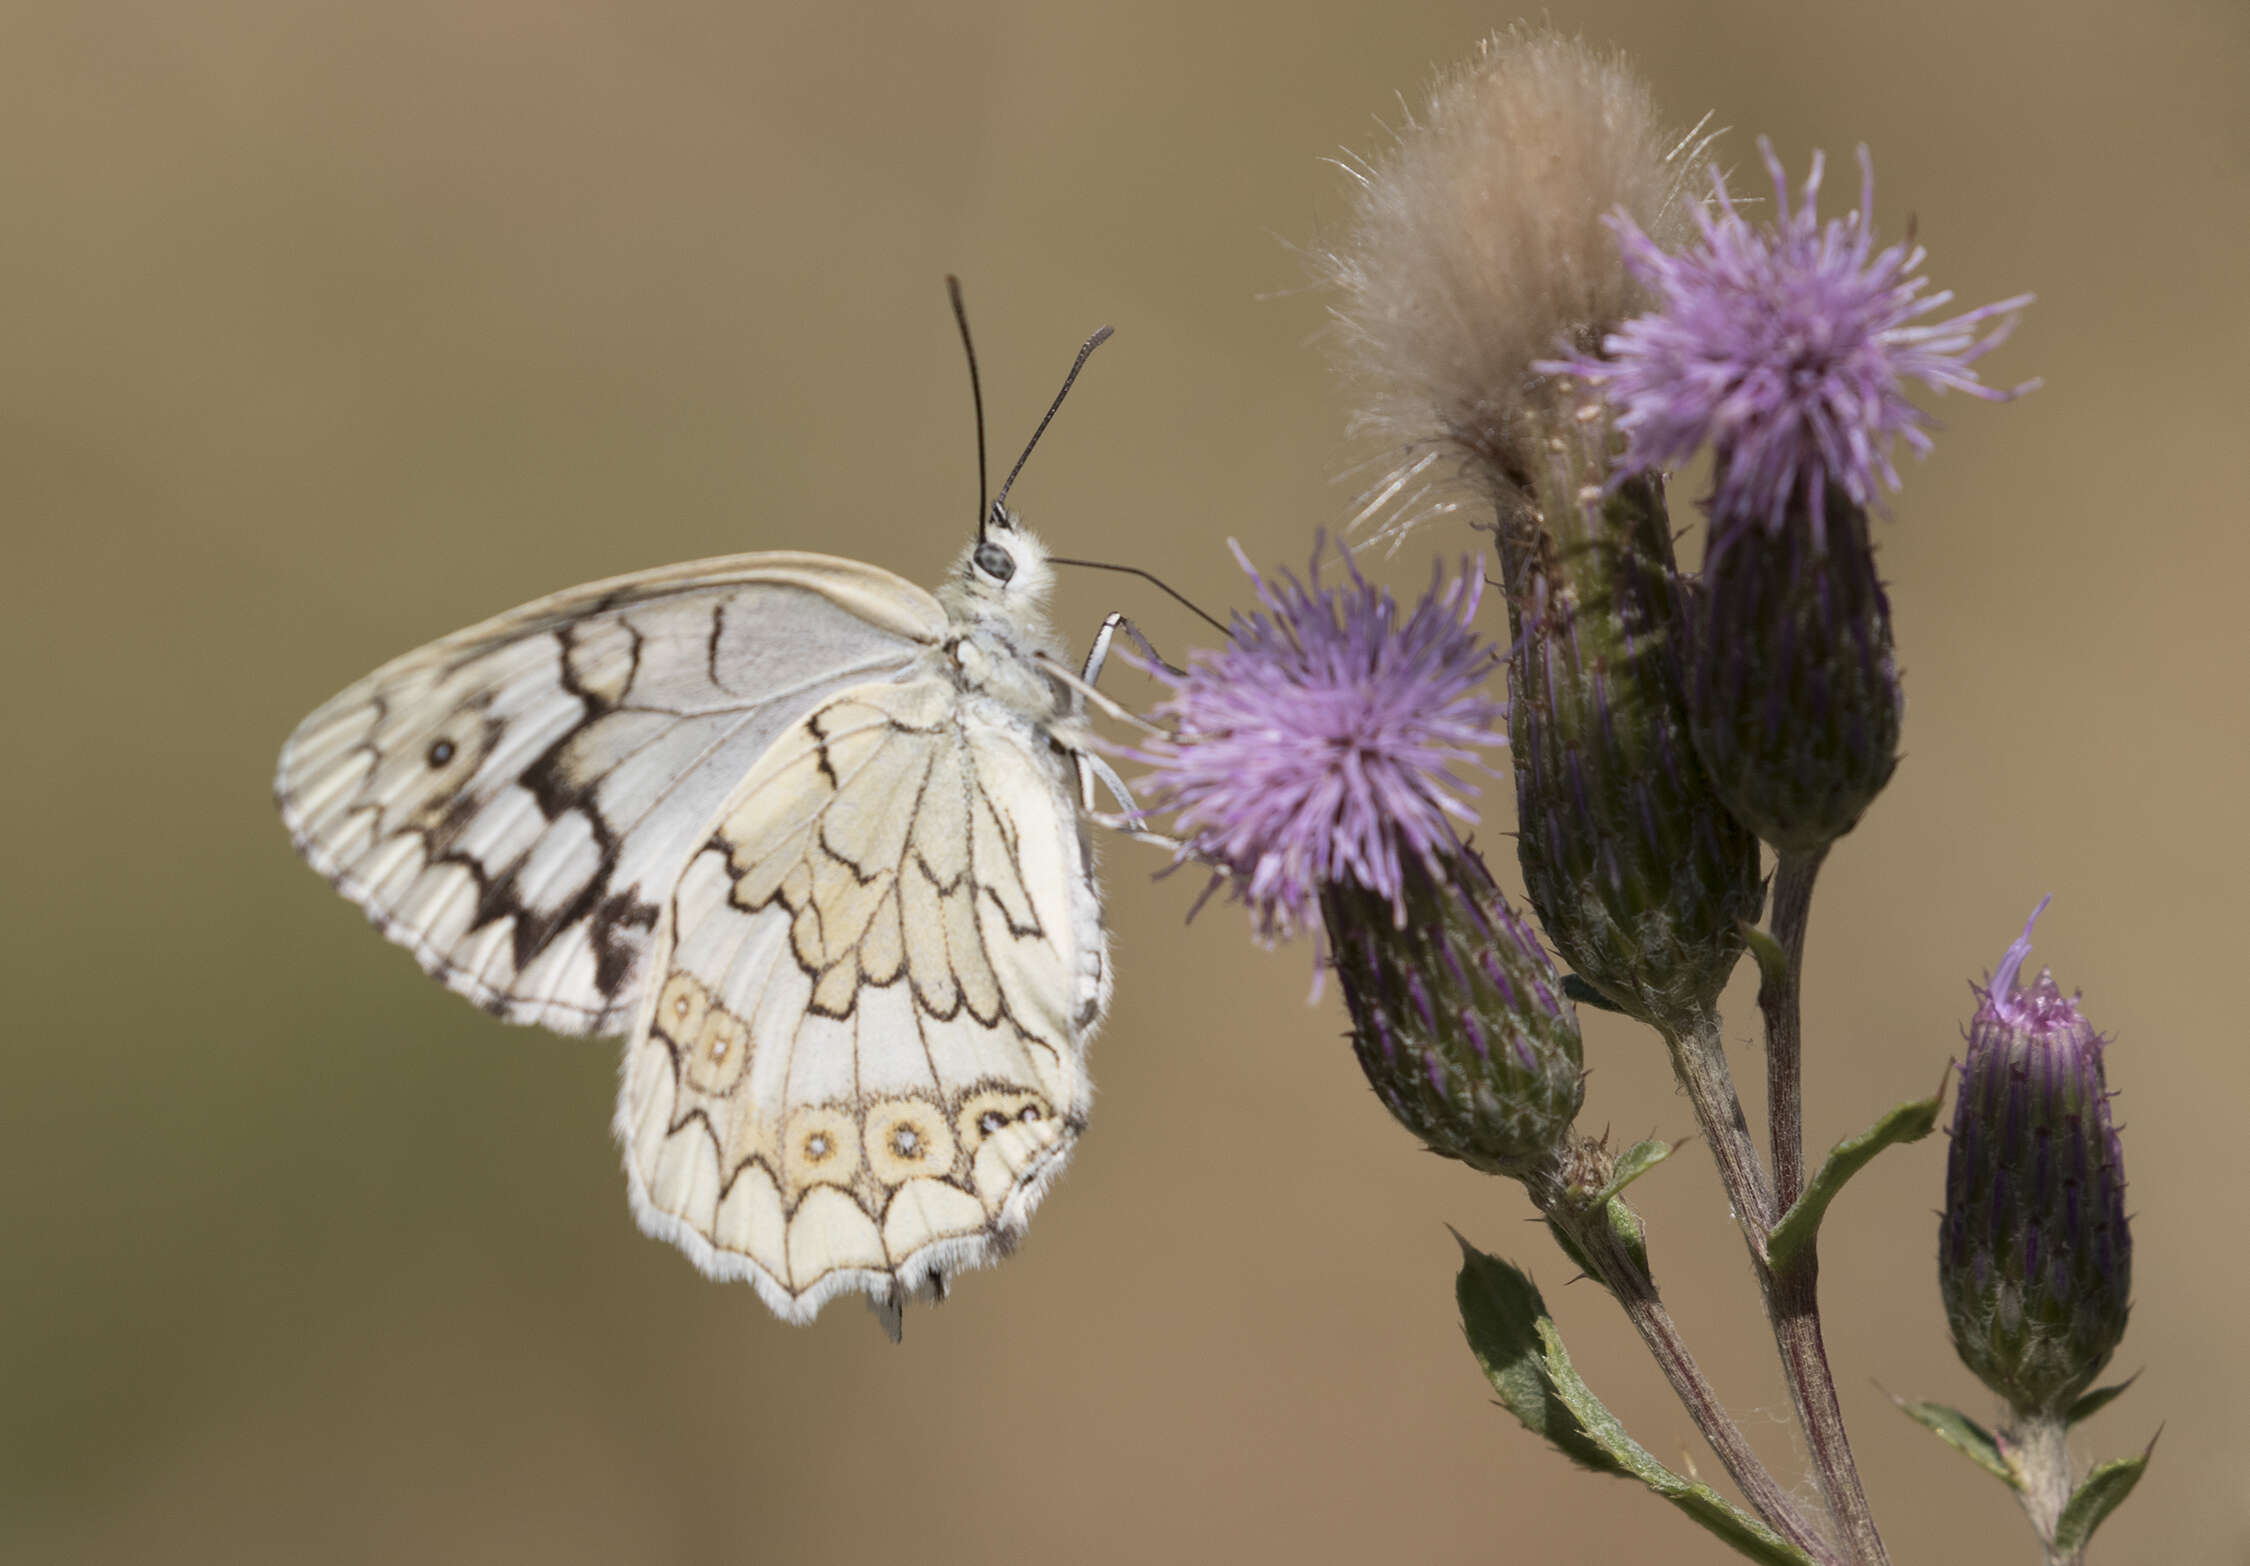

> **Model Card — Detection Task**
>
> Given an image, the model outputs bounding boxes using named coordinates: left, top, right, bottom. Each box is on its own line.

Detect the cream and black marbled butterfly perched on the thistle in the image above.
left=275, top=288, right=1130, bottom=1337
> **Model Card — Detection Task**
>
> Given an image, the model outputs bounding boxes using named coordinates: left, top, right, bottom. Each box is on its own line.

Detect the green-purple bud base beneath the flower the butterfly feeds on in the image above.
left=1321, top=848, right=1586, bottom=1179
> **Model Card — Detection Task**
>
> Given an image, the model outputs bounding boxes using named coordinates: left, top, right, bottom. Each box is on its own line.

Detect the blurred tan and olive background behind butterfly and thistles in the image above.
left=0, top=0, right=2250, bottom=1566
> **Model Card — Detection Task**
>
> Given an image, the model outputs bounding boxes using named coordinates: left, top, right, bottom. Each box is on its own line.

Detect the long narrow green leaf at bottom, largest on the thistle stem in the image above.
left=1454, top=1233, right=1811, bottom=1566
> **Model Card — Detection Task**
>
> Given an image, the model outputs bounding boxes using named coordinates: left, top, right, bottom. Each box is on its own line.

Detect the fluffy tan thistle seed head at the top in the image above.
left=1316, top=27, right=1685, bottom=526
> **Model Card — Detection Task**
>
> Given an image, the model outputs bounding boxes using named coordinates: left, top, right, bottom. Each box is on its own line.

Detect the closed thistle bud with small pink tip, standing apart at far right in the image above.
left=1937, top=902, right=2133, bottom=1420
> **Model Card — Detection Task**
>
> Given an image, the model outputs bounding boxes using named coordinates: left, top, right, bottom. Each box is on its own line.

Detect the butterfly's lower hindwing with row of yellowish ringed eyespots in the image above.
left=617, top=677, right=1109, bottom=1321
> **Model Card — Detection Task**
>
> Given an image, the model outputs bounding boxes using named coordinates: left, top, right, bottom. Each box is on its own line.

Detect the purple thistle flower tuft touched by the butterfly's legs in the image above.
left=1132, top=545, right=1503, bottom=941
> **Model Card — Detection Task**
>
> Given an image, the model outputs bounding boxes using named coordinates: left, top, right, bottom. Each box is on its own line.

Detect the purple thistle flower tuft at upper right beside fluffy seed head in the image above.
left=1537, top=137, right=2039, bottom=533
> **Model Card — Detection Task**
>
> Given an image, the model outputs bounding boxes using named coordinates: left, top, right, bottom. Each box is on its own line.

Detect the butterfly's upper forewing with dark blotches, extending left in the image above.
left=275, top=554, right=945, bottom=1033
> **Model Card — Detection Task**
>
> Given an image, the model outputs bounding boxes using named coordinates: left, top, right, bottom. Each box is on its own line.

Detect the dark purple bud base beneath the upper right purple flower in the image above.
left=1688, top=491, right=1904, bottom=853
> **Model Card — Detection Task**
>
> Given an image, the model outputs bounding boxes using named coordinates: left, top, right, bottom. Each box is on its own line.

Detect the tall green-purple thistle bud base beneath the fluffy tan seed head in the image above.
left=1499, top=434, right=1764, bottom=1033
